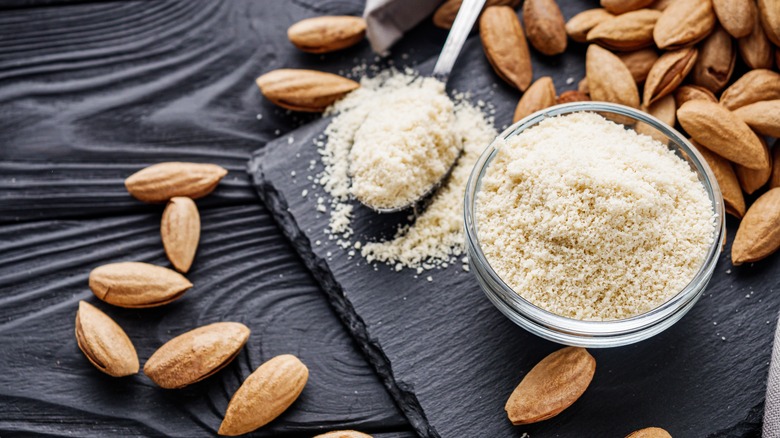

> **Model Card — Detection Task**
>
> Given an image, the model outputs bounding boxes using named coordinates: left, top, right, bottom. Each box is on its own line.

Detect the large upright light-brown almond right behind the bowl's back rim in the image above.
left=585, top=44, right=639, bottom=108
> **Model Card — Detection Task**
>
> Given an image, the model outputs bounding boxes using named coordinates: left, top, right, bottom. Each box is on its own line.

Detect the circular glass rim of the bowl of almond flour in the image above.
left=464, top=102, right=725, bottom=337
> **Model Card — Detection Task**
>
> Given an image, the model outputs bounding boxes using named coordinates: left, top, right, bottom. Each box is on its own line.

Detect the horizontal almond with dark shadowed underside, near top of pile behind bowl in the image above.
left=587, top=9, right=661, bottom=51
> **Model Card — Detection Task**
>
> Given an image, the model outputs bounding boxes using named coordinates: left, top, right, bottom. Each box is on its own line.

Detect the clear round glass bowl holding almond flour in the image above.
left=464, top=102, right=725, bottom=348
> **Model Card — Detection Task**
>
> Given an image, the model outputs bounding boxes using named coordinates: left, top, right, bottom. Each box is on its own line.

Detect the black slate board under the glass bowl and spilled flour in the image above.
left=249, top=2, right=780, bottom=437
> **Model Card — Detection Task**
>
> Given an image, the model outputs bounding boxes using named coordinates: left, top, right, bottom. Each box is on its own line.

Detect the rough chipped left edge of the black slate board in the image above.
left=247, top=149, right=432, bottom=437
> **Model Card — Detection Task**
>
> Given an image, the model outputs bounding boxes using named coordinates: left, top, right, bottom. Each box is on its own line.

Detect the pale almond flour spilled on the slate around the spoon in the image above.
left=314, top=69, right=497, bottom=275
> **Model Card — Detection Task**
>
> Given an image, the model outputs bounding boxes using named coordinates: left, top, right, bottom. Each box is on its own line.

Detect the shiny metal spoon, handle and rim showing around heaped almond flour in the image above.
left=358, top=0, right=486, bottom=213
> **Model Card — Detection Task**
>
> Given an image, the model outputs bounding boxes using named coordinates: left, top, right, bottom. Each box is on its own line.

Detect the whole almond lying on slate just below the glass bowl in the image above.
left=504, top=347, right=596, bottom=426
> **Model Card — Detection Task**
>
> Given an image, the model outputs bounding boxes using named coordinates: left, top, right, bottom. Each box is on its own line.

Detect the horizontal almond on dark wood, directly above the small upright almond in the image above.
left=125, top=162, right=227, bottom=202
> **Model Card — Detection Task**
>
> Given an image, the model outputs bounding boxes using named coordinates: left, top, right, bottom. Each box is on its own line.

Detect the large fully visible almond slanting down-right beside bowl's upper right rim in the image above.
left=677, top=100, right=767, bottom=169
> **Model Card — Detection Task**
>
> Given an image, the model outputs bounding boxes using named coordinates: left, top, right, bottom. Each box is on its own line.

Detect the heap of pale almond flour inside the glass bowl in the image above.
left=476, top=113, right=715, bottom=320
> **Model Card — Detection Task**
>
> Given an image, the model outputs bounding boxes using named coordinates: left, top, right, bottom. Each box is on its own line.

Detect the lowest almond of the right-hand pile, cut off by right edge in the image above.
left=731, top=187, right=780, bottom=266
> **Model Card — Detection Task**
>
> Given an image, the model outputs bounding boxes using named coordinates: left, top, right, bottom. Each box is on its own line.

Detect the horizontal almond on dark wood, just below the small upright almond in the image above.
left=89, top=262, right=192, bottom=308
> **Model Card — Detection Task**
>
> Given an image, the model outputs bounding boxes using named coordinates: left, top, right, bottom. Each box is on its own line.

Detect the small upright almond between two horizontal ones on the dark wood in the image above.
left=160, top=196, right=200, bottom=273
